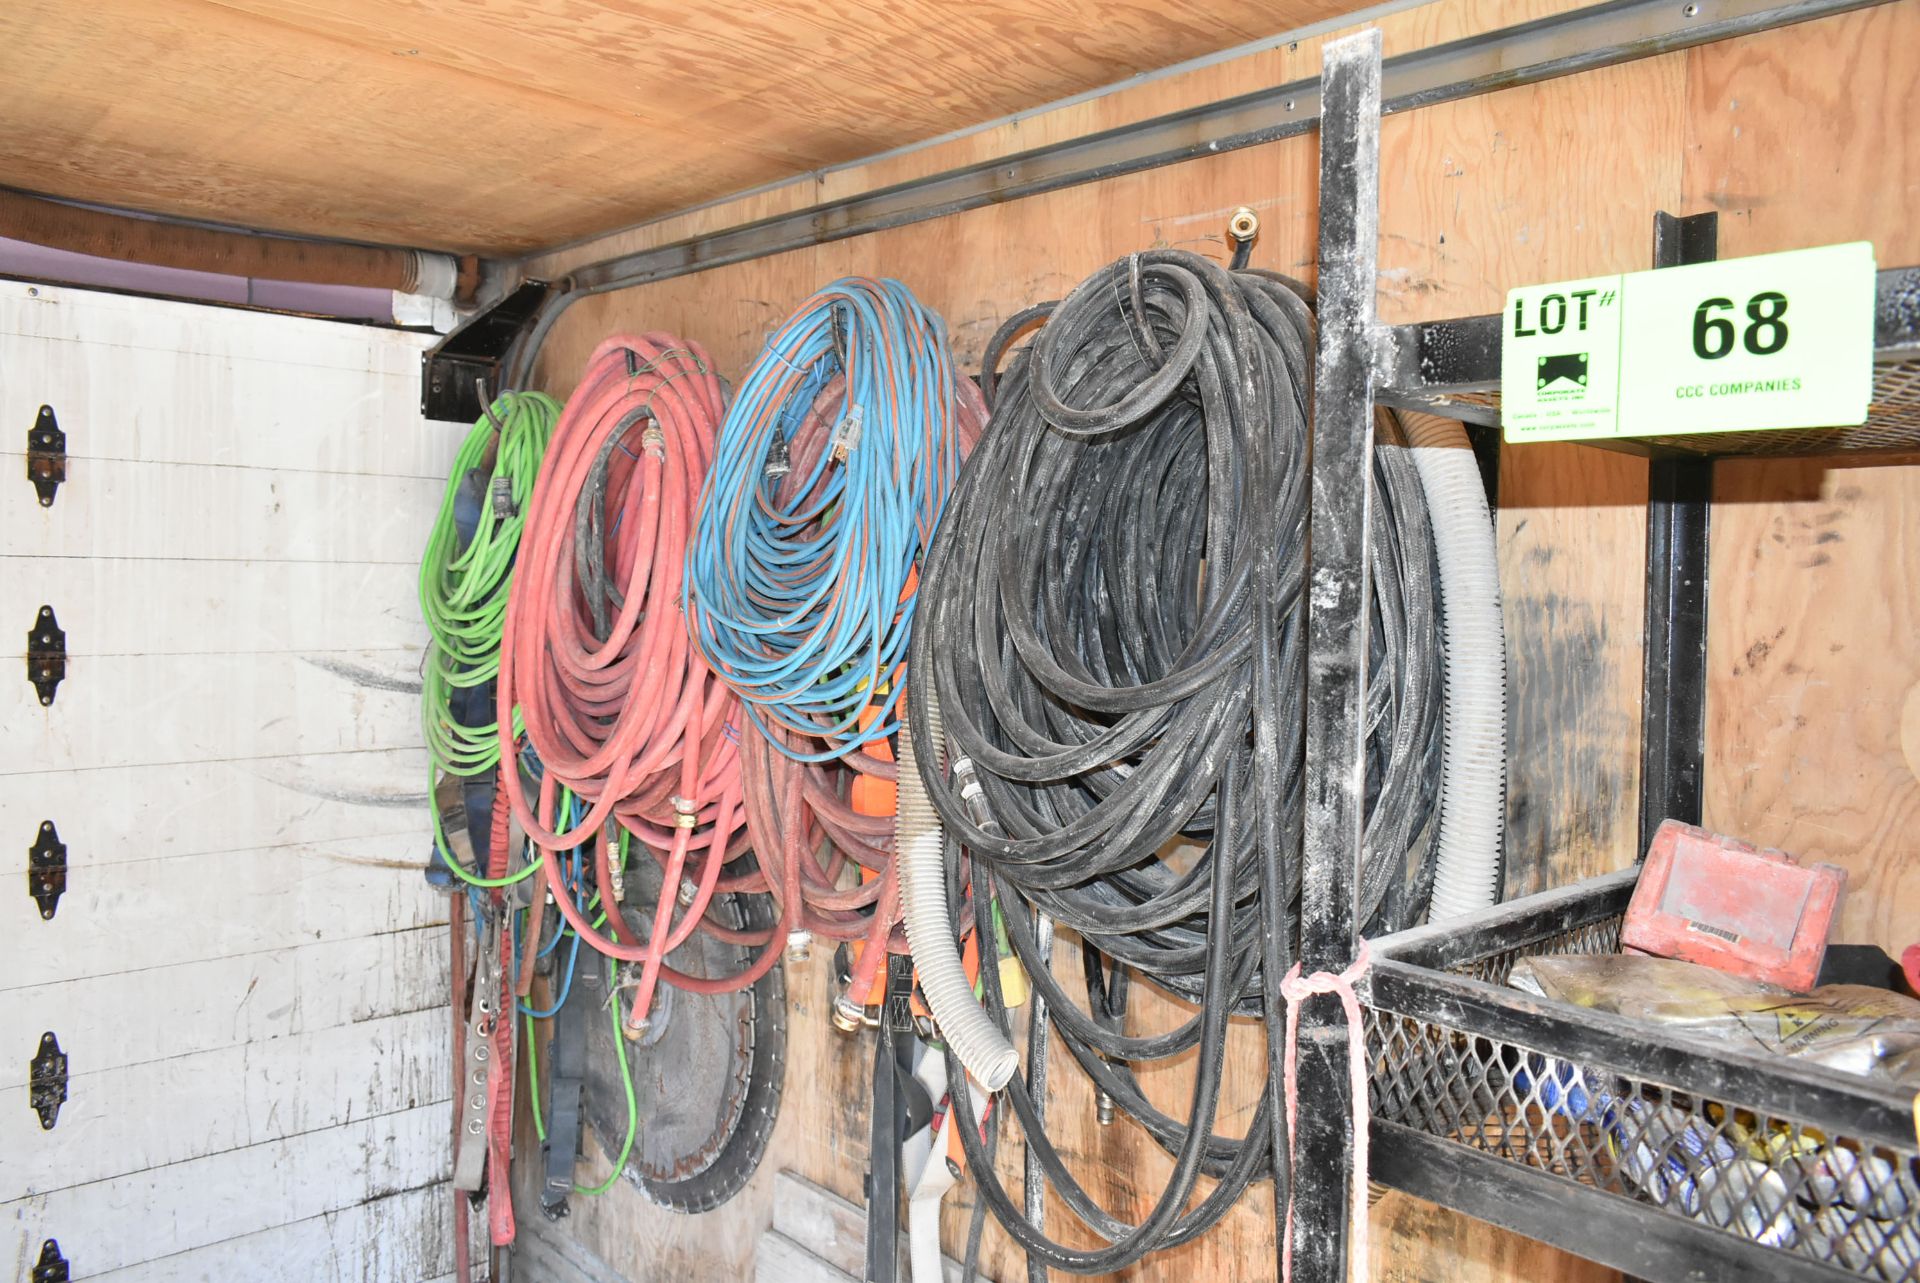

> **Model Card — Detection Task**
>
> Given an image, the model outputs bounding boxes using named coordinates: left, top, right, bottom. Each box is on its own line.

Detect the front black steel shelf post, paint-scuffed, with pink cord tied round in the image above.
left=1290, top=31, right=1380, bottom=1283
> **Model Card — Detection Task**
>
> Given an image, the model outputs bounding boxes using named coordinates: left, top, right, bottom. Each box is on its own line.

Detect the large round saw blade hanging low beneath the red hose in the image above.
left=582, top=855, right=787, bottom=1212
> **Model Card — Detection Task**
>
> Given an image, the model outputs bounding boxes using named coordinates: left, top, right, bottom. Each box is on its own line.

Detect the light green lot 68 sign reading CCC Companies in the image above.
left=1500, top=242, right=1874, bottom=442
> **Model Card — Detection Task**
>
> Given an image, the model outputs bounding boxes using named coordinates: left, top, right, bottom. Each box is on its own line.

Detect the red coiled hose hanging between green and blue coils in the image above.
left=499, top=334, right=780, bottom=1028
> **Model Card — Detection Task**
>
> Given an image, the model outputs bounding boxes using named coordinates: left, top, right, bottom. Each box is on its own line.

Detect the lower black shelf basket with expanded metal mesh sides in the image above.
left=1367, top=870, right=1920, bottom=1283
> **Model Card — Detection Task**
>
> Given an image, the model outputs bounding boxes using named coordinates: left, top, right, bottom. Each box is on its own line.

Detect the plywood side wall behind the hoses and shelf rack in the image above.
left=518, top=0, right=1920, bottom=1283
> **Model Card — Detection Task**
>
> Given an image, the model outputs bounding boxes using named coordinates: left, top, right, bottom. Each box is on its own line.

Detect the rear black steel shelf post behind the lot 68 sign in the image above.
left=1640, top=213, right=1718, bottom=859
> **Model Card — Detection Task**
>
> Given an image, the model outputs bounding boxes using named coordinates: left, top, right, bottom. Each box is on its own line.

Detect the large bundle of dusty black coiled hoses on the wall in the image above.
left=908, top=250, right=1442, bottom=1273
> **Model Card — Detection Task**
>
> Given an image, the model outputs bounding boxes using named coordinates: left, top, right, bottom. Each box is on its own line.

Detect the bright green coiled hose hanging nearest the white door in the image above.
left=420, top=392, right=561, bottom=882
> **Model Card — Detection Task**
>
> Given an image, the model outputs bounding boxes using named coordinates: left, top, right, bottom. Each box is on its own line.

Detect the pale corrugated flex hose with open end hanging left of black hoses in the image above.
left=893, top=682, right=1020, bottom=1091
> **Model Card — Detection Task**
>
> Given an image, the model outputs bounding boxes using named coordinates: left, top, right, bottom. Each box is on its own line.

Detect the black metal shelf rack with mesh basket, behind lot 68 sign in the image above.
left=1294, top=33, right=1920, bottom=1283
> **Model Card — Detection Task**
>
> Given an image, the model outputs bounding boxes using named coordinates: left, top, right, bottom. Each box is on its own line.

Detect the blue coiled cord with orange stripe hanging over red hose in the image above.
left=685, top=277, right=960, bottom=763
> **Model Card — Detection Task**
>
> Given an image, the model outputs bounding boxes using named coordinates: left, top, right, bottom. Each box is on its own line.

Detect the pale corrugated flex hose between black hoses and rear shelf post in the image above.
left=1405, top=415, right=1507, bottom=922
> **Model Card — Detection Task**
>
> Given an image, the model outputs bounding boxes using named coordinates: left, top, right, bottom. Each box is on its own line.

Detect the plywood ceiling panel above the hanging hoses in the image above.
left=0, top=0, right=1357, bottom=254
